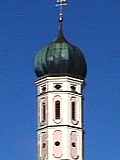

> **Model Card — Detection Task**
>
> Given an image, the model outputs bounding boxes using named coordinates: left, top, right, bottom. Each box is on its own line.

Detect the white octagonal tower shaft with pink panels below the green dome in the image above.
left=35, top=76, right=84, bottom=160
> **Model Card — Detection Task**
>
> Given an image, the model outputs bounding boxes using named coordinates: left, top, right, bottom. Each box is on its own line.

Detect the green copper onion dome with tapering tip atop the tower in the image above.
left=34, top=24, right=87, bottom=79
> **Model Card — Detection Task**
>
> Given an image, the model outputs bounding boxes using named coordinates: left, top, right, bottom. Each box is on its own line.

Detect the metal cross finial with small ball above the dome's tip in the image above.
left=56, top=0, right=67, bottom=22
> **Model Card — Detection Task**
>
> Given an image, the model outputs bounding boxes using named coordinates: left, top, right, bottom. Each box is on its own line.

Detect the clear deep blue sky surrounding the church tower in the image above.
left=0, top=0, right=120, bottom=160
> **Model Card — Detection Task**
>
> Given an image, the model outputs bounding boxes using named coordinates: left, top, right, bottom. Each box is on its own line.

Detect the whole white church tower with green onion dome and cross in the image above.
left=34, top=0, right=87, bottom=160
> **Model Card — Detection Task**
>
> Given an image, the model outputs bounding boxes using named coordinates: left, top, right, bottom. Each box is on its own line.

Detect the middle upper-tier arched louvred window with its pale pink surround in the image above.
left=53, top=96, right=62, bottom=123
